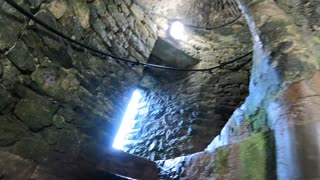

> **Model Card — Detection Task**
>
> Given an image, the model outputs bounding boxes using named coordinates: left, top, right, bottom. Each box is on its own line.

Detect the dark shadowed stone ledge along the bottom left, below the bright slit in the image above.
left=0, top=152, right=158, bottom=180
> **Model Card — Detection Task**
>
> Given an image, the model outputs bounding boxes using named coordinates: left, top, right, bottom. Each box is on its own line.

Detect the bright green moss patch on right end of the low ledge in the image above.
left=240, top=132, right=277, bottom=180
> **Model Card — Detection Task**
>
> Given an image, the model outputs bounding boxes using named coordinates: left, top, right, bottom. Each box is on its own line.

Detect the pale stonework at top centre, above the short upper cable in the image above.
left=136, top=0, right=241, bottom=29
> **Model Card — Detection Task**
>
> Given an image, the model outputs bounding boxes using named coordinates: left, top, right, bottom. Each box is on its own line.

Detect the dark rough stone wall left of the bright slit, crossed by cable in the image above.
left=0, top=0, right=157, bottom=167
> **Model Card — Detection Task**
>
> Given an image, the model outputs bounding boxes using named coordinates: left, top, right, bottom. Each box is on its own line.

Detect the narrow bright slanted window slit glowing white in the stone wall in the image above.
left=112, top=90, right=142, bottom=150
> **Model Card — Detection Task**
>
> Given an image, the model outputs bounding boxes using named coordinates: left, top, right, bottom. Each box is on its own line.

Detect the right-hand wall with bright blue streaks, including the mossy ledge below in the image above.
left=159, top=0, right=320, bottom=179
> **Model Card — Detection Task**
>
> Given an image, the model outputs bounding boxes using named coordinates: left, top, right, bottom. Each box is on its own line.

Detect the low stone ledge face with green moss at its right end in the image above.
left=158, top=132, right=276, bottom=180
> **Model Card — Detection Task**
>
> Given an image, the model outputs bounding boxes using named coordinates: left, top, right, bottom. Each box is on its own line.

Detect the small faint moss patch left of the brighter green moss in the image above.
left=214, top=147, right=229, bottom=179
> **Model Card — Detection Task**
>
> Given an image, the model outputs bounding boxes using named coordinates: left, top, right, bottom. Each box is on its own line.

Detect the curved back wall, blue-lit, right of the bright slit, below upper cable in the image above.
left=125, top=11, right=251, bottom=160
